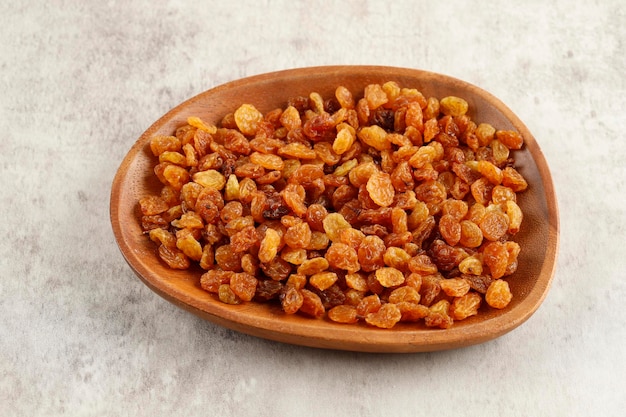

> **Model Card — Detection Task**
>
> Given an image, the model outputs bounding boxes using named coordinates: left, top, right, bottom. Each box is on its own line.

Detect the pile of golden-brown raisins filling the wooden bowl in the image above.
left=139, top=82, right=527, bottom=328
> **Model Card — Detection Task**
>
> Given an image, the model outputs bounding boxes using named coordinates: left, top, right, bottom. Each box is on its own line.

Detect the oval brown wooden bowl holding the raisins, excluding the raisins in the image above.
left=110, top=66, right=559, bottom=352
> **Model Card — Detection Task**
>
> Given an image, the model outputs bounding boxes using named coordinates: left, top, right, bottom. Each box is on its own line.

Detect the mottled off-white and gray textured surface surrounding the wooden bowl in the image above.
left=0, top=0, right=626, bottom=416
